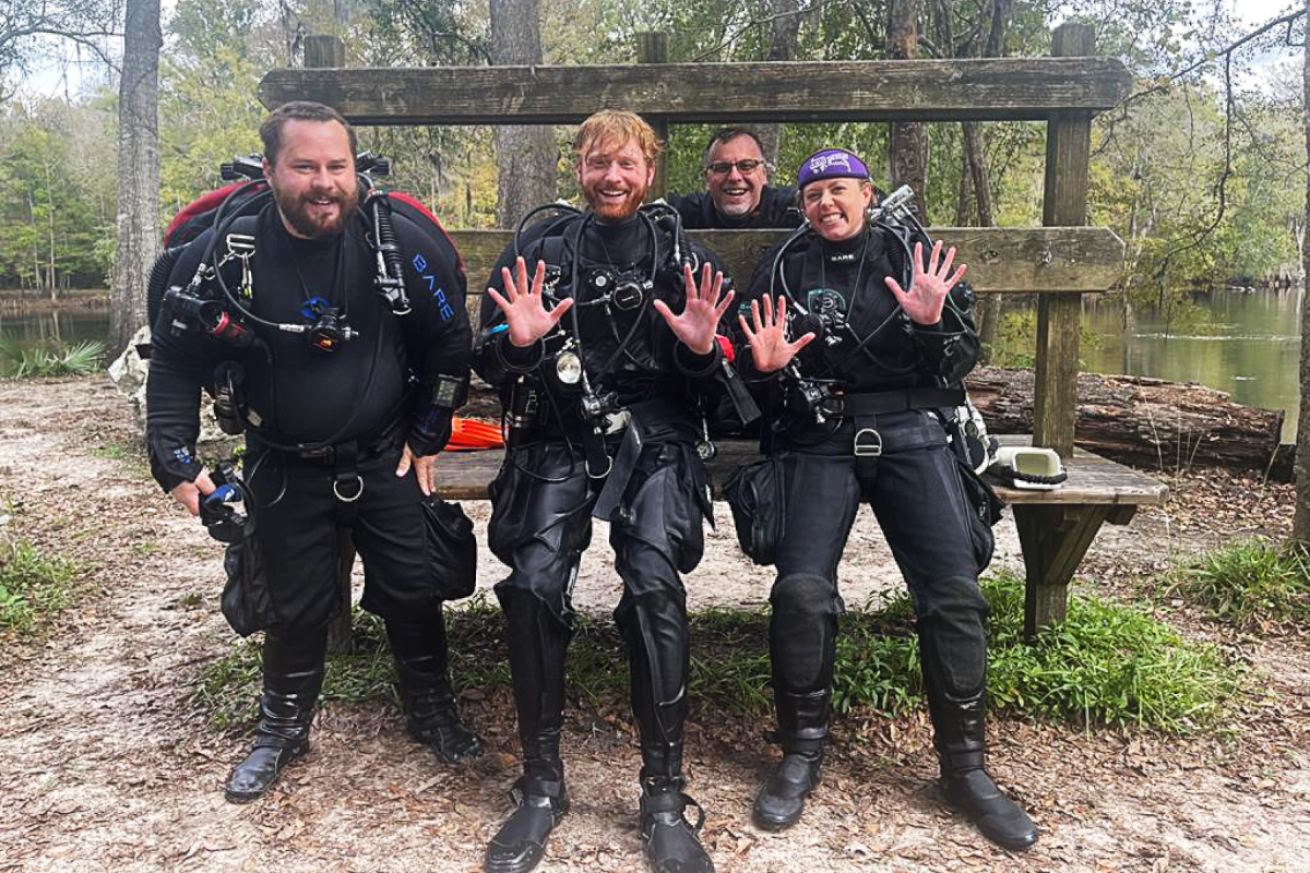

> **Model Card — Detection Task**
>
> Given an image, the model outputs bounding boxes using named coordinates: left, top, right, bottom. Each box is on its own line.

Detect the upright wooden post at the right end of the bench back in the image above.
left=1032, top=24, right=1095, bottom=457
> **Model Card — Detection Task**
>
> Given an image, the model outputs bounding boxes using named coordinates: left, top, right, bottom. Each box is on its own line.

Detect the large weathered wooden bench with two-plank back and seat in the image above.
left=259, top=22, right=1165, bottom=632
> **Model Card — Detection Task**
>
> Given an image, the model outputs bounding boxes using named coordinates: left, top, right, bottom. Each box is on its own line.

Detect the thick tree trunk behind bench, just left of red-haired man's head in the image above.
left=489, top=0, right=558, bottom=228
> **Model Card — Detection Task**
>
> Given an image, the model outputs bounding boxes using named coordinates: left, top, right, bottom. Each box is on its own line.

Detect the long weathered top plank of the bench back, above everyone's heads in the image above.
left=259, top=58, right=1131, bottom=125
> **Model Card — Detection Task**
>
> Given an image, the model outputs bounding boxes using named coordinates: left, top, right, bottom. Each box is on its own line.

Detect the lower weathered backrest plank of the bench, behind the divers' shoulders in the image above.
left=451, top=227, right=1124, bottom=294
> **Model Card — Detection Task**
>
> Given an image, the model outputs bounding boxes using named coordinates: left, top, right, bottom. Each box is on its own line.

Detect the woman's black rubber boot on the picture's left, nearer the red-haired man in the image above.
left=755, top=689, right=832, bottom=831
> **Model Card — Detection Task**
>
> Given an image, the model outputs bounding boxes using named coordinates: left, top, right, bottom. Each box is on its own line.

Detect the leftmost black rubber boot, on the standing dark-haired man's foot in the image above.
left=224, top=631, right=328, bottom=804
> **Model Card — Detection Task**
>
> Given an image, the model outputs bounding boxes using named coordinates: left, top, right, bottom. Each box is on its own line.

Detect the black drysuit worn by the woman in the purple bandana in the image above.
left=738, top=225, right=988, bottom=751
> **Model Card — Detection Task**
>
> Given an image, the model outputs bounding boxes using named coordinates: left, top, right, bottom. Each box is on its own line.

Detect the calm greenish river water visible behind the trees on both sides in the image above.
left=0, top=290, right=1305, bottom=442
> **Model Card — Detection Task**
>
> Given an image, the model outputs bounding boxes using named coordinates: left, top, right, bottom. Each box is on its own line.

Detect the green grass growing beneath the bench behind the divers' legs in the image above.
left=194, top=575, right=1242, bottom=733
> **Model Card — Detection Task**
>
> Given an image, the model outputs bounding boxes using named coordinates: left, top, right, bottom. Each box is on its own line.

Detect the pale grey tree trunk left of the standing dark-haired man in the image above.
left=109, top=0, right=164, bottom=354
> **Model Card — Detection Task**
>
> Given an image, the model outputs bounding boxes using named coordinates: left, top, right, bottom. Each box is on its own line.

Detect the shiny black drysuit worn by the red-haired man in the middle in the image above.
left=474, top=212, right=721, bottom=797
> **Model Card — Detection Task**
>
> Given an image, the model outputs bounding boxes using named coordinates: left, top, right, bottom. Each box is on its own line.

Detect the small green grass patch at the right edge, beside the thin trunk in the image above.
left=1166, top=537, right=1310, bottom=629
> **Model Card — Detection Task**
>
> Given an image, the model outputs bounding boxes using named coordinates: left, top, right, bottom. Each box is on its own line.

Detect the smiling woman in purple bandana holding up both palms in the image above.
left=738, top=148, right=1038, bottom=849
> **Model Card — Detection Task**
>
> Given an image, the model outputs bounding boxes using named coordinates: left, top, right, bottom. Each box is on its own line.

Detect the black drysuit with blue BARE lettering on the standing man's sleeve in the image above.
left=148, top=199, right=472, bottom=637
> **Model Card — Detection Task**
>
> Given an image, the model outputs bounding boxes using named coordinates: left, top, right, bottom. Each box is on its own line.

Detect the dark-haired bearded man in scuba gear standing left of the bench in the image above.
left=148, top=102, right=481, bottom=804
